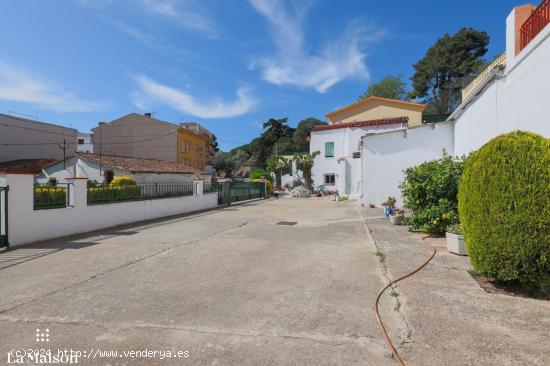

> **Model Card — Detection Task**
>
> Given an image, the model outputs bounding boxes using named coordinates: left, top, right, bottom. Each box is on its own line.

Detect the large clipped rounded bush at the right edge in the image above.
left=458, top=131, right=550, bottom=294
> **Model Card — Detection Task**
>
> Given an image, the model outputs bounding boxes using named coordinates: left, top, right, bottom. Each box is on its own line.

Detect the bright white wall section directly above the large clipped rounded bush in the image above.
left=454, top=19, right=550, bottom=155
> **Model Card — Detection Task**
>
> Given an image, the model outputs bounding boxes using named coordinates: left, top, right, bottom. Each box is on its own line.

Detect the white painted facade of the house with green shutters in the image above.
left=309, top=123, right=406, bottom=198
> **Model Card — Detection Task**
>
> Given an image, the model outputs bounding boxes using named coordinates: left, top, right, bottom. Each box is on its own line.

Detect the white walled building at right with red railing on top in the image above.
left=362, top=0, right=550, bottom=205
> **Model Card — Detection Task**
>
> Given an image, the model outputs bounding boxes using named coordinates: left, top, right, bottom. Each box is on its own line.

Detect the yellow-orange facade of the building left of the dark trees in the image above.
left=178, top=127, right=210, bottom=170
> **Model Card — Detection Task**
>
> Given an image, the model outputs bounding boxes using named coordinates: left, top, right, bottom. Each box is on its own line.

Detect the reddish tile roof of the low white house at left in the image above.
left=77, top=153, right=200, bottom=174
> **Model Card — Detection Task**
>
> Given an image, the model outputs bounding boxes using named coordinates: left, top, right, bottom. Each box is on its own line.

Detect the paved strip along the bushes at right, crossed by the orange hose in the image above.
left=363, top=209, right=550, bottom=365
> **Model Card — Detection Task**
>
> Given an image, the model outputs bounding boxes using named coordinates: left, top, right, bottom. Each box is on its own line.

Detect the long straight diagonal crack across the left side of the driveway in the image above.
left=0, top=220, right=254, bottom=314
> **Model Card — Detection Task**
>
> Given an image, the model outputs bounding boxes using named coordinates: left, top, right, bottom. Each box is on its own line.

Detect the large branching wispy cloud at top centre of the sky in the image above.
left=250, top=0, right=379, bottom=93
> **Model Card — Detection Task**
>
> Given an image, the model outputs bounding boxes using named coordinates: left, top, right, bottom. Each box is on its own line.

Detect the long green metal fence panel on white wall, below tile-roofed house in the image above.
left=87, top=183, right=195, bottom=205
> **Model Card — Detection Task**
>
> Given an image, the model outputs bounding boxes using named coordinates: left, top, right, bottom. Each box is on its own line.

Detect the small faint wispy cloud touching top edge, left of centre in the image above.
left=141, top=0, right=218, bottom=37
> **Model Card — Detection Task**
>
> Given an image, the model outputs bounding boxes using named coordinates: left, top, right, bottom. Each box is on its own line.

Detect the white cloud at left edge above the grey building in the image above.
left=0, top=62, right=102, bottom=112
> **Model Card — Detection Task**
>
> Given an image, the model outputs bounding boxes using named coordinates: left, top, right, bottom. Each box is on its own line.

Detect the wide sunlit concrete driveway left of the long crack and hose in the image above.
left=0, top=198, right=398, bottom=365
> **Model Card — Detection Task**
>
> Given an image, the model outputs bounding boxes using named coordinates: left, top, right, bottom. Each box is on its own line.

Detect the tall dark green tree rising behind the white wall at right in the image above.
left=411, top=28, right=489, bottom=114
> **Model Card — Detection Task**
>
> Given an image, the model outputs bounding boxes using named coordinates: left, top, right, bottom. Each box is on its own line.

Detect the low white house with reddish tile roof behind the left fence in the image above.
left=35, top=153, right=203, bottom=184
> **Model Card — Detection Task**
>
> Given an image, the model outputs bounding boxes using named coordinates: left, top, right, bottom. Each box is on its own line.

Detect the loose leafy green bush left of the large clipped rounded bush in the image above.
left=399, top=154, right=464, bottom=235
